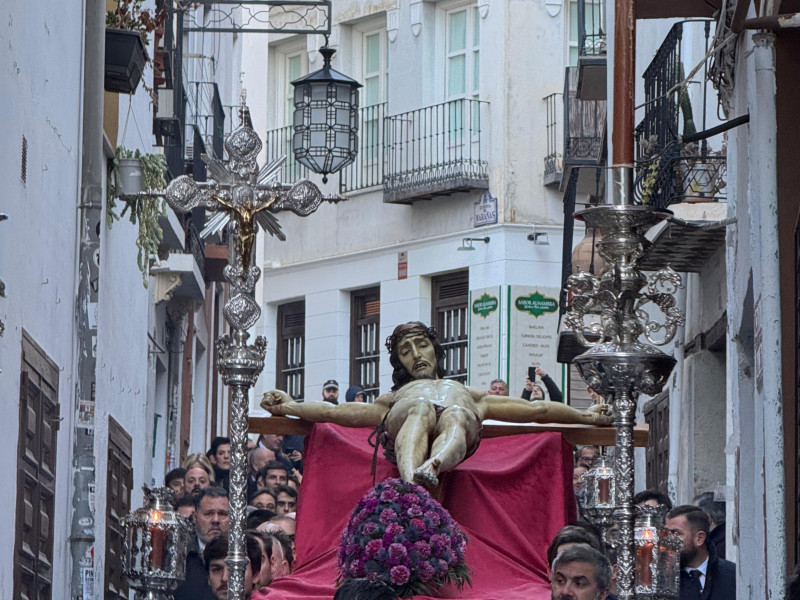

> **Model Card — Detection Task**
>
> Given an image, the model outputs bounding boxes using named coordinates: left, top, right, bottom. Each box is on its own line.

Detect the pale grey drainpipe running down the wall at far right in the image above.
left=748, top=32, right=786, bottom=598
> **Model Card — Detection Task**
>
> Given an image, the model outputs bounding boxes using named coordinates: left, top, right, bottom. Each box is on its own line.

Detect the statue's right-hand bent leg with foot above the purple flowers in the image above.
left=414, top=405, right=480, bottom=487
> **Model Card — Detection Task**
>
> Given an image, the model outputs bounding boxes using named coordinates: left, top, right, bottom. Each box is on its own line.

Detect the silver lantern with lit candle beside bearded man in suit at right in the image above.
left=633, top=506, right=682, bottom=600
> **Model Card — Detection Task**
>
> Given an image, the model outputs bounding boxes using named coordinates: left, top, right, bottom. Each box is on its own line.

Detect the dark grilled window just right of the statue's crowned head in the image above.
left=431, top=271, right=469, bottom=383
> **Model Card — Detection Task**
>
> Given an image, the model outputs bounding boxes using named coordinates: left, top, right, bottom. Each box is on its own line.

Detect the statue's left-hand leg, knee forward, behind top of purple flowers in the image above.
left=387, top=402, right=436, bottom=481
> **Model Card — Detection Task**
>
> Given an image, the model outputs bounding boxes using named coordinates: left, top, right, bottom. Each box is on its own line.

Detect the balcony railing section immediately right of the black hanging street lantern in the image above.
left=339, top=102, right=386, bottom=193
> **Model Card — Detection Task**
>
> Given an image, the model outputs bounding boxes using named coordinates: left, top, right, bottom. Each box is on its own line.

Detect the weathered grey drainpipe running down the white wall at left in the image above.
left=69, top=0, right=106, bottom=600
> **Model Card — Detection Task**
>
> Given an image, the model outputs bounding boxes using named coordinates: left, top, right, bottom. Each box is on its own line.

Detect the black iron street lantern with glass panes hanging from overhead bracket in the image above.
left=292, top=44, right=361, bottom=183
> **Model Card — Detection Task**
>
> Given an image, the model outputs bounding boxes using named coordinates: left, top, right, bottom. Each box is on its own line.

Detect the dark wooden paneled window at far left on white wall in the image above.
left=13, top=331, right=59, bottom=600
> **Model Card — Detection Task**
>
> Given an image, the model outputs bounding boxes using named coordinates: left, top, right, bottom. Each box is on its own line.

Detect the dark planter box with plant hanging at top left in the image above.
left=105, top=0, right=167, bottom=94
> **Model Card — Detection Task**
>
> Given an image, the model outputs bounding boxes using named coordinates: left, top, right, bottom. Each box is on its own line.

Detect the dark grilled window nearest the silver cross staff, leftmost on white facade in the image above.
left=276, top=300, right=306, bottom=400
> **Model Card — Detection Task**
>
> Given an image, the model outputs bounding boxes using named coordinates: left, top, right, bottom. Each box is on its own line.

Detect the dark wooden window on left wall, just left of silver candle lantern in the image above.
left=104, top=417, right=133, bottom=600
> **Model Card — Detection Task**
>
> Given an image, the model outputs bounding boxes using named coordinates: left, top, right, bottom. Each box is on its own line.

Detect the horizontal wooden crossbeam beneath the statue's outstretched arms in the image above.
left=248, top=417, right=649, bottom=448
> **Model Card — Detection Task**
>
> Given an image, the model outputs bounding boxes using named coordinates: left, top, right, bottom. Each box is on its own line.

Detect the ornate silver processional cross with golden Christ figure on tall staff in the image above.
left=166, top=103, right=342, bottom=600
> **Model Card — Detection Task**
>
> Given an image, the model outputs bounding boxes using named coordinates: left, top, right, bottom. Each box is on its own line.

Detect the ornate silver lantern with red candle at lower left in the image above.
left=122, top=485, right=193, bottom=600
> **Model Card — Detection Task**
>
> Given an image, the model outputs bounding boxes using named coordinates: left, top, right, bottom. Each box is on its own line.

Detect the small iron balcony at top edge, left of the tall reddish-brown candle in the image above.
left=577, top=0, right=607, bottom=100
